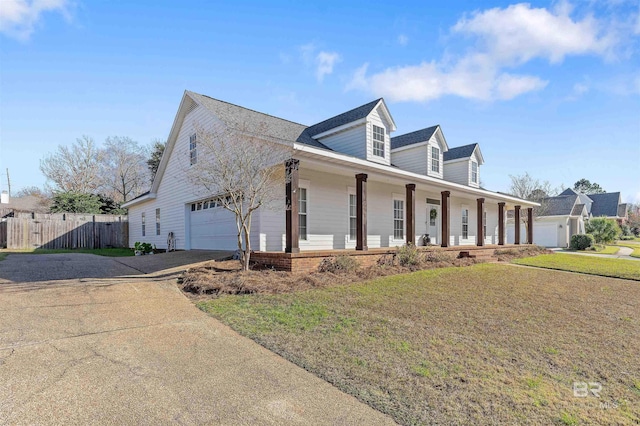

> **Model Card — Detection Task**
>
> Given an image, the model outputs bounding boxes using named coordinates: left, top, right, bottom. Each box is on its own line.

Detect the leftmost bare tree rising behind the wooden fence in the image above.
left=40, top=136, right=103, bottom=194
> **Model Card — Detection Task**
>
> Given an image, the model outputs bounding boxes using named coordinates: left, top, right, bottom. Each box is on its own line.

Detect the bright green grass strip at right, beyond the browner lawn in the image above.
left=513, top=253, right=640, bottom=281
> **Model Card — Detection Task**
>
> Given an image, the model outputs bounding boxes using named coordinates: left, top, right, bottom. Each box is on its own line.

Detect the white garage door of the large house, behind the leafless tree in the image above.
left=189, top=201, right=238, bottom=250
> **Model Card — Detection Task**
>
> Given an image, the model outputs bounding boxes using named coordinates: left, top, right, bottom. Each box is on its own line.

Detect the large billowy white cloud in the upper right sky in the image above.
left=347, top=2, right=616, bottom=102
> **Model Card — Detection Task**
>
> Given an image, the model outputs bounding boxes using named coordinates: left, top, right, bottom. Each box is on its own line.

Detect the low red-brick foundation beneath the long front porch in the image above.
left=251, top=245, right=526, bottom=273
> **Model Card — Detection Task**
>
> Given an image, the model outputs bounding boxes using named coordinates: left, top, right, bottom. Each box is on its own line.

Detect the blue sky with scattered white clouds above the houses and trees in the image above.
left=0, top=0, right=640, bottom=202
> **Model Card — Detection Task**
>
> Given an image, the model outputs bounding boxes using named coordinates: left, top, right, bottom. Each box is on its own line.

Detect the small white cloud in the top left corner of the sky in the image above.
left=0, top=0, right=69, bottom=41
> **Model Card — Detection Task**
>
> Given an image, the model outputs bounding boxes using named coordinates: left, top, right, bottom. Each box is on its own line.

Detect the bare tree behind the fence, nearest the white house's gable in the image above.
left=101, top=136, right=149, bottom=203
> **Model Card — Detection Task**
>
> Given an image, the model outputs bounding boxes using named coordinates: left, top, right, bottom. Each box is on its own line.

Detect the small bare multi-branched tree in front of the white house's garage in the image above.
left=187, top=124, right=293, bottom=270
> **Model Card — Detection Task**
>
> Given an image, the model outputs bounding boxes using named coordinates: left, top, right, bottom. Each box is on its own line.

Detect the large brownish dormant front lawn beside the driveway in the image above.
left=198, top=264, right=640, bottom=424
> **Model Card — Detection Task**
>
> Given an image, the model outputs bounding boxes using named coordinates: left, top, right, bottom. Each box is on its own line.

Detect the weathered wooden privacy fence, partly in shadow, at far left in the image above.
left=0, top=213, right=129, bottom=250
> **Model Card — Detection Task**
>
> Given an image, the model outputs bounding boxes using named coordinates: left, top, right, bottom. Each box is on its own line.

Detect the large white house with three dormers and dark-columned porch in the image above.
left=123, top=91, right=537, bottom=252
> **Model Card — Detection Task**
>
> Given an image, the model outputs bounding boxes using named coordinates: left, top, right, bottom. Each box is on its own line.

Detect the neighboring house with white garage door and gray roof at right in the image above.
left=507, top=188, right=627, bottom=247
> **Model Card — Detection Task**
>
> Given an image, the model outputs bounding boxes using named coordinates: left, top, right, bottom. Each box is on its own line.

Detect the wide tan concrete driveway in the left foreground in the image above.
left=0, top=254, right=393, bottom=425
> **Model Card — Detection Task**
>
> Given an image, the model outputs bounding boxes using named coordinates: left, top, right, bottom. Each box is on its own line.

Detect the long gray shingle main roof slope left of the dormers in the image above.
left=187, top=91, right=329, bottom=149
